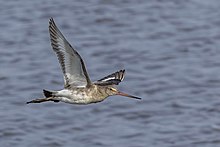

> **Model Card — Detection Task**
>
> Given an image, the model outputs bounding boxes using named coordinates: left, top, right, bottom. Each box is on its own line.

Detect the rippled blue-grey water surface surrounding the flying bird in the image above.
left=0, top=0, right=220, bottom=147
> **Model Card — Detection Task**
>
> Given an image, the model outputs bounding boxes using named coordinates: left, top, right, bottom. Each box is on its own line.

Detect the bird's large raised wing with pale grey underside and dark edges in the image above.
left=49, top=18, right=91, bottom=88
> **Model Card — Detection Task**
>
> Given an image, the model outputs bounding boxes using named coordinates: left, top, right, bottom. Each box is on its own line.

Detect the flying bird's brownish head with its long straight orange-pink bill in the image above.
left=106, top=86, right=141, bottom=99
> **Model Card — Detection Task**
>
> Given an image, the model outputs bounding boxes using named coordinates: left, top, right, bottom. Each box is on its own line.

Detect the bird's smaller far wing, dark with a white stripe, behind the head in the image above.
left=94, top=70, right=125, bottom=85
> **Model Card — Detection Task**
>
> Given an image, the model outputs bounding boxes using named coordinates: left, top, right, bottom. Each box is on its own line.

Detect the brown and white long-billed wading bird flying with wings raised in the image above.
left=26, top=17, right=141, bottom=105
